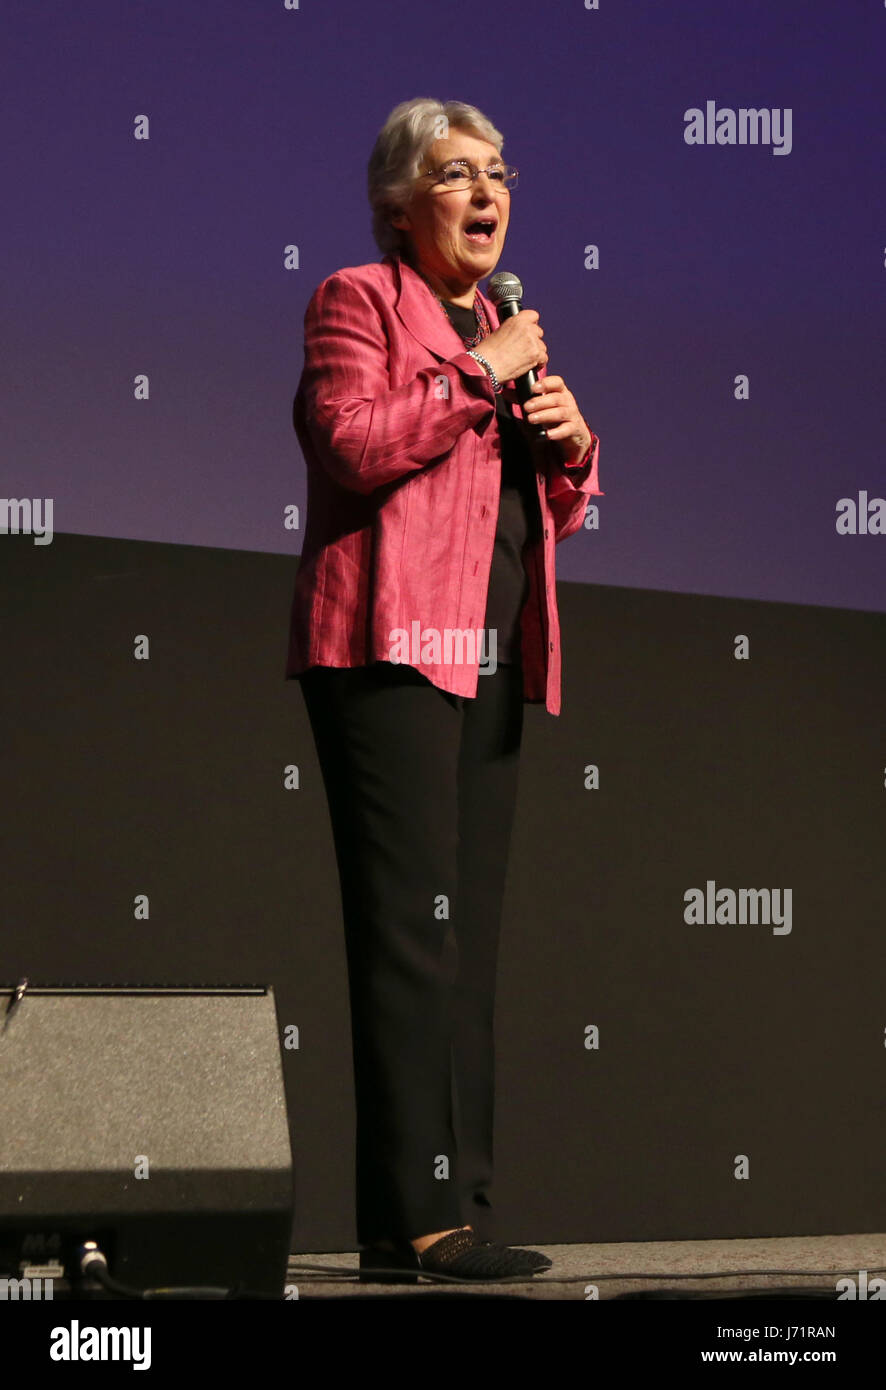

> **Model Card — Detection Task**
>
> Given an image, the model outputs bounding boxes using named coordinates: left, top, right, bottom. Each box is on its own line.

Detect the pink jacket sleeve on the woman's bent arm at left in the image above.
left=295, top=271, right=495, bottom=493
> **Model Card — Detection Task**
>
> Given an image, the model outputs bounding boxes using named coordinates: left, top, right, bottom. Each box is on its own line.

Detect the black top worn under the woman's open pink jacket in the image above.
left=442, top=300, right=541, bottom=666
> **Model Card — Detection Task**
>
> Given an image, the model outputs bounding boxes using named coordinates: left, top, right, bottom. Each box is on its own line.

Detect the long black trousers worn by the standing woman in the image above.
left=300, top=662, right=523, bottom=1245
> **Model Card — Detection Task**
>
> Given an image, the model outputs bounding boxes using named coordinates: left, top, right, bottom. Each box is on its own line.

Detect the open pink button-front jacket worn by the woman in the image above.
left=285, top=248, right=602, bottom=714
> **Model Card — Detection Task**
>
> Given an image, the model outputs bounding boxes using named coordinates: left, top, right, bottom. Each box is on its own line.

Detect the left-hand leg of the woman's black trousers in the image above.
left=300, top=663, right=467, bottom=1244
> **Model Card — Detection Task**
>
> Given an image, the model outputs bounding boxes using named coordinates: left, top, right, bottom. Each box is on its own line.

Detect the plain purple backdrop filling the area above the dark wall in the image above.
left=0, top=0, right=886, bottom=609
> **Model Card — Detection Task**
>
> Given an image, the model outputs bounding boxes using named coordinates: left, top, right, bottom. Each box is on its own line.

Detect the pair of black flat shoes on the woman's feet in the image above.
left=360, top=1230, right=551, bottom=1284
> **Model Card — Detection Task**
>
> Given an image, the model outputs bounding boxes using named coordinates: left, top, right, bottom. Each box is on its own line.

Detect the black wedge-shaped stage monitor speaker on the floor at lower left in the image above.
left=0, top=981, right=293, bottom=1297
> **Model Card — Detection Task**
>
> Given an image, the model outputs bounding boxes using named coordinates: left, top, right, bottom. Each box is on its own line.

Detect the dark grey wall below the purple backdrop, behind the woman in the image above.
left=0, top=535, right=886, bottom=1251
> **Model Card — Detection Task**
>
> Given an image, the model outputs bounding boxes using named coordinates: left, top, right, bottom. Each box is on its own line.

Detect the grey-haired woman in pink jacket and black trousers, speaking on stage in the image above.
left=287, top=99, right=601, bottom=1282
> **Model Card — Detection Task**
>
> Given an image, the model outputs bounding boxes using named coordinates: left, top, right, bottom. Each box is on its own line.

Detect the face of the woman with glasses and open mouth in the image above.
left=392, top=126, right=510, bottom=286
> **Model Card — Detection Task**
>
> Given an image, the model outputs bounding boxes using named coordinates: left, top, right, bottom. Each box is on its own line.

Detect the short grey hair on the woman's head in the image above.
left=369, top=96, right=505, bottom=256
